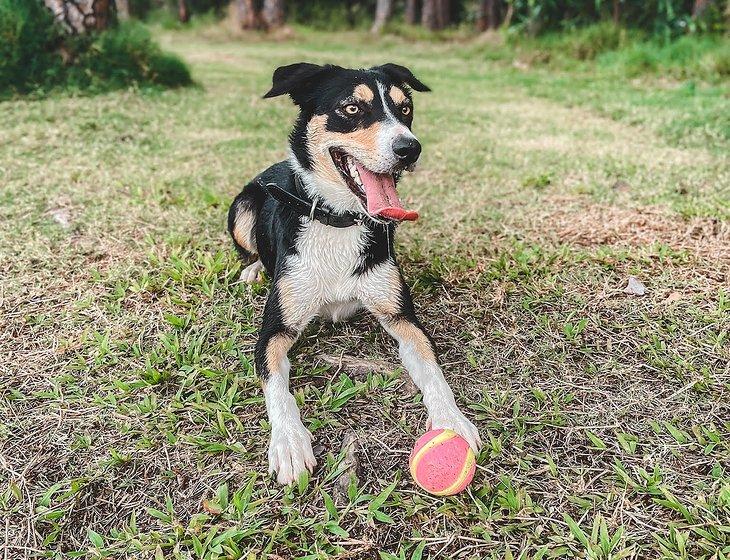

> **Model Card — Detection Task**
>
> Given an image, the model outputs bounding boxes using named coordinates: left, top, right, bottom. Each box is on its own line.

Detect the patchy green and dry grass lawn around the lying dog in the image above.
left=0, top=23, right=730, bottom=560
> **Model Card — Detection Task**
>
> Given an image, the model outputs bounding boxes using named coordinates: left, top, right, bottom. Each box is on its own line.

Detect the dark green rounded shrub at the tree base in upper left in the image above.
left=0, top=0, right=192, bottom=96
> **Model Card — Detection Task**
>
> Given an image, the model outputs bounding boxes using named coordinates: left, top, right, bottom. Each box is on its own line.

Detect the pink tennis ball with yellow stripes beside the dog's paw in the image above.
left=408, top=430, right=477, bottom=496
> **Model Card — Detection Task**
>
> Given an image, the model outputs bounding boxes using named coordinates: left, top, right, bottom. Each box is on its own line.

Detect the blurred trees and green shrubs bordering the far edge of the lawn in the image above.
left=0, top=0, right=730, bottom=97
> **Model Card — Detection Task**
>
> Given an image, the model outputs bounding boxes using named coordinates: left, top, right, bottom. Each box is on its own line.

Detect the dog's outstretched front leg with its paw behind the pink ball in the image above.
left=365, top=264, right=482, bottom=451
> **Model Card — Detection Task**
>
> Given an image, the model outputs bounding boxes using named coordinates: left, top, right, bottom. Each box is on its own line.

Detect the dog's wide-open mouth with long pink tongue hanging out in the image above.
left=330, top=148, right=418, bottom=222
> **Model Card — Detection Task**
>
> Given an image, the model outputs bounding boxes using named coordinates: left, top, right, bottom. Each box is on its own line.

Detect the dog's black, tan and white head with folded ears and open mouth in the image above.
left=264, top=62, right=429, bottom=221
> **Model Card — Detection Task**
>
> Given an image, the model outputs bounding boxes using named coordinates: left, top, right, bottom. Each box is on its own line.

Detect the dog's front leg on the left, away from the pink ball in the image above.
left=255, top=282, right=317, bottom=484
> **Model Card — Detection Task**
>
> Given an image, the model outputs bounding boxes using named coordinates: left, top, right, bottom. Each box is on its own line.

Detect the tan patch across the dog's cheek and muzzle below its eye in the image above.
left=307, top=115, right=380, bottom=187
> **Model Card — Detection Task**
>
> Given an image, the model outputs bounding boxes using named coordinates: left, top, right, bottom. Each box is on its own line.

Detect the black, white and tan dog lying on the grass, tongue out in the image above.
left=228, top=63, right=481, bottom=484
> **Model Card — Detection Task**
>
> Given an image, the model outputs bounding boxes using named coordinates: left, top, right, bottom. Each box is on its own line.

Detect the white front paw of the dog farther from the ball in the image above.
left=269, top=421, right=317, bottom=484
